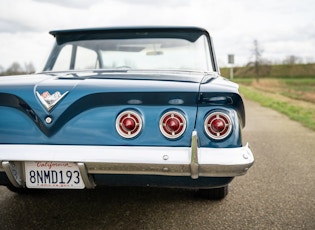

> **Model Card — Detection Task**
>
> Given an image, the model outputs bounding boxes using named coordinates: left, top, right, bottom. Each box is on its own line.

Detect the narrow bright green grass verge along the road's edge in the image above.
left=240, top=86, right=315, bottom=131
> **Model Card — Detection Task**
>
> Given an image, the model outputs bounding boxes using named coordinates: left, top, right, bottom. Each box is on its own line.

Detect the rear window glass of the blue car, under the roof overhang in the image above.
left=45, top=34, right=213, bottom=71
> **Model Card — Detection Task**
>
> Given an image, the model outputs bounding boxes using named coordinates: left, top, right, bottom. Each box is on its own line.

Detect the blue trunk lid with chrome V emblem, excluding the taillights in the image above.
left=2, top=73, right=212, bottom=146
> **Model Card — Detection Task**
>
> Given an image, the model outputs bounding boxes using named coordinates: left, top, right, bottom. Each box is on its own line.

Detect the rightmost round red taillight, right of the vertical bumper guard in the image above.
left=204, top=112, right=232, bottom=140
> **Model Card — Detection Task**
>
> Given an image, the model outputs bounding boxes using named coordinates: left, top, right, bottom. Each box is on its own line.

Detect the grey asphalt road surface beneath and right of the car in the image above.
left=0, top=101, right=315, bottom=230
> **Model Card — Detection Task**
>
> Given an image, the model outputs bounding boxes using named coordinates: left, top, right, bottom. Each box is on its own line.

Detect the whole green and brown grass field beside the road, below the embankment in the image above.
left=235, top=77, right=315, bottom=130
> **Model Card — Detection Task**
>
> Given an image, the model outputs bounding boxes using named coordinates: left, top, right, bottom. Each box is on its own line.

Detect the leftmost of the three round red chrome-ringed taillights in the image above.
left=116, top=110, right=142, bottom=138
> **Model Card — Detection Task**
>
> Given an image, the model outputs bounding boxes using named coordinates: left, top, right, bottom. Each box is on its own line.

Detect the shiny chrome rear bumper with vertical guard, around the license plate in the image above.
left=0, top=132, right=254, bottom=188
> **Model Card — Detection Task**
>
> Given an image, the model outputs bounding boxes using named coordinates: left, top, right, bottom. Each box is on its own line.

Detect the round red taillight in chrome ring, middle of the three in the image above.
left=160, top=111, right=186, bottom=139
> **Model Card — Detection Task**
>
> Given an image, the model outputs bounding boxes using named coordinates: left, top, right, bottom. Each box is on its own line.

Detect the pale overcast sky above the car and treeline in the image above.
left=0, top=0, right=315, bottom=71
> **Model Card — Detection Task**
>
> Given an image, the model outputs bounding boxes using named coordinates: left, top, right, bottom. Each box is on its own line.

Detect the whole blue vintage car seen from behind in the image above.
left=0, top=27, right=254, bottom=199
